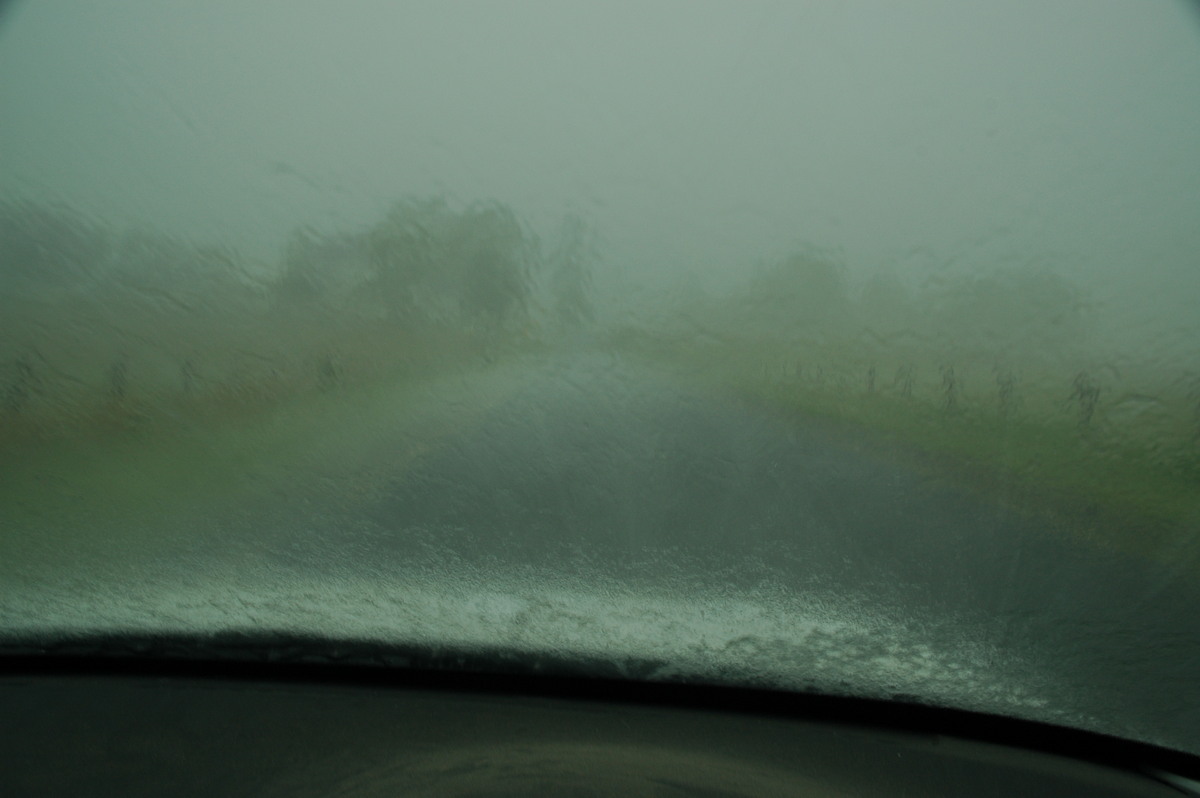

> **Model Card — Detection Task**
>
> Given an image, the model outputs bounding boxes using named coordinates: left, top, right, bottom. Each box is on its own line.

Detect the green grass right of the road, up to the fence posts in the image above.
left=616, top=326, right=1200, bottom=558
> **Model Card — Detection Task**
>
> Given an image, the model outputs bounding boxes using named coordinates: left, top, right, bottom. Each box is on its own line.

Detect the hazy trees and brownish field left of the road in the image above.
left=0, top=197, right=588, bottom=443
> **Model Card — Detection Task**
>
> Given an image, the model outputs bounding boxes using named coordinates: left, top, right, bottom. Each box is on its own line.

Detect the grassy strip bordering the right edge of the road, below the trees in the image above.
left=613, top=330, right=1200, bottom=564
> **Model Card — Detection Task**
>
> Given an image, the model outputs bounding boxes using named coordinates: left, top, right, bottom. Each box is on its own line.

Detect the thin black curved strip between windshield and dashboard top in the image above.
left=0, top=634, right=1200, bottom=794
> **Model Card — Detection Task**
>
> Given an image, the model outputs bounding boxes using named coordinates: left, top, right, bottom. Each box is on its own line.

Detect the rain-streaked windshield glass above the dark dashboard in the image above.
left=0, top=0, right=1200, bottom=752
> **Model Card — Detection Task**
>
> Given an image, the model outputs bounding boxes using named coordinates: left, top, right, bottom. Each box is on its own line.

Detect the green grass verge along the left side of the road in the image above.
left=0, top=328, right=540, bottom=574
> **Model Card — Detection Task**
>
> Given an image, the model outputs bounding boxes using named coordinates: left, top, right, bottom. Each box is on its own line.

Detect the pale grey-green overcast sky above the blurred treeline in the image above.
left=0, top=0, right=1200, bottom=324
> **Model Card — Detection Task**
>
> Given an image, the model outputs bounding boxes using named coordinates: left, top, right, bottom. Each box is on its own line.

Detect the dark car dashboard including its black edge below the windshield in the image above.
left=0, top=641, right=1200, bottom=798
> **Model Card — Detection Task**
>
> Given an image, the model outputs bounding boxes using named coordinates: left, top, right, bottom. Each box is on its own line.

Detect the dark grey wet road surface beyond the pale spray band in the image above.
left=248, top=356, right=1200, bottom=739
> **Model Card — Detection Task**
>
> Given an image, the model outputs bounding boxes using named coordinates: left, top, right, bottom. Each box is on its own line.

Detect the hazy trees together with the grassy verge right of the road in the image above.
left=610, top=250, right=1200, bottom=552
